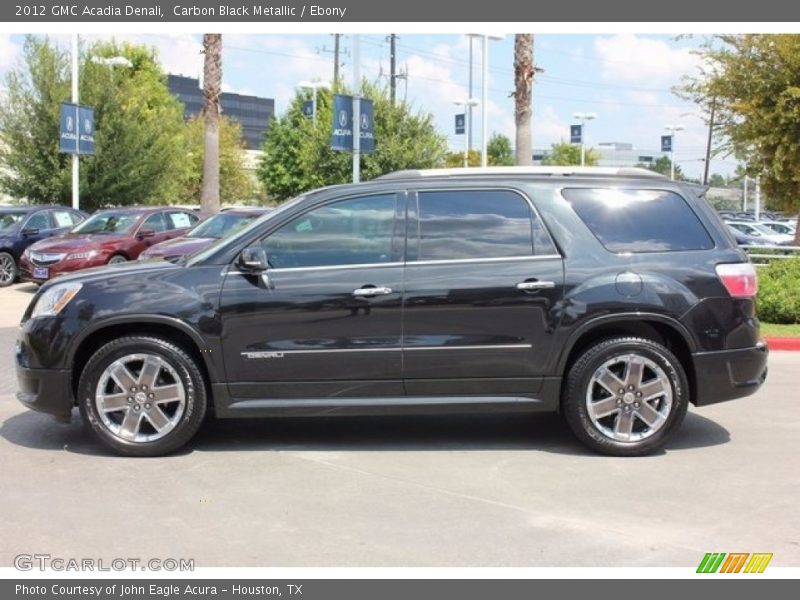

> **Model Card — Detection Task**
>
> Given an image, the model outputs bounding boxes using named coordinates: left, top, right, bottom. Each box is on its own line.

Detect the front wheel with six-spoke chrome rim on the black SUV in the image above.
left=78, top=336, right=207, bottom=456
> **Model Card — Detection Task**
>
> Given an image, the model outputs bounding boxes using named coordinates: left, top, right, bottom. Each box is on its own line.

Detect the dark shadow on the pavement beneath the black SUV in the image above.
left=0, top=411, right=730, bottom=457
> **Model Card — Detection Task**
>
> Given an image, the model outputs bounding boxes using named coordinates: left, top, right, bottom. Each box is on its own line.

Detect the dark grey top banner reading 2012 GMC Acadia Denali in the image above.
left=0, top=0, right=800, bottom=22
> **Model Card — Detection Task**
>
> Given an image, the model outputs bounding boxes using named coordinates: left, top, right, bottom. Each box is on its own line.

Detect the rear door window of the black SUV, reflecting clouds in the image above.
left=417, top=189, right=556, bottom=261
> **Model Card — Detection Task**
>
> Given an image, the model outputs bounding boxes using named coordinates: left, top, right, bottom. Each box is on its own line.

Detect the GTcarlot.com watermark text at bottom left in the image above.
left=14, top=554, right=194, bottom=571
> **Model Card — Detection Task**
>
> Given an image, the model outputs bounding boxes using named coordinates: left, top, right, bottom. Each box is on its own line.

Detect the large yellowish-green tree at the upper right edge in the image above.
left=677, top=34, right=800, bottom=243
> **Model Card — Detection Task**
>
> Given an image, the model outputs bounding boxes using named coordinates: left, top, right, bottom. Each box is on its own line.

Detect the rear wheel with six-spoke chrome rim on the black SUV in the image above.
left=562, top=337, right=690, bottom=456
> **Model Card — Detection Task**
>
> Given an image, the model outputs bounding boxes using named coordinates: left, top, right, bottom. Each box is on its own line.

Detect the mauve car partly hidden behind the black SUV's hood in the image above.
left=139, top=208, right=270, bottom=260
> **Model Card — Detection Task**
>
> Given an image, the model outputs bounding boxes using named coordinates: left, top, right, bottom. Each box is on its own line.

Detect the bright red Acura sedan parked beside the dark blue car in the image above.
left=20, top=208, right=199, bottom=283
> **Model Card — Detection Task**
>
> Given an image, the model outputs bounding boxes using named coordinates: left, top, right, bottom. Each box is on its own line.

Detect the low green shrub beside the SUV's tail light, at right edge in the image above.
left=758, top=258, right=800, bottom=324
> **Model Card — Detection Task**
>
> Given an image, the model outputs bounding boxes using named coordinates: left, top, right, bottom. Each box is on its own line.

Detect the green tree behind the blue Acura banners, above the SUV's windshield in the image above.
left=257, top=83, right=447, bottom=199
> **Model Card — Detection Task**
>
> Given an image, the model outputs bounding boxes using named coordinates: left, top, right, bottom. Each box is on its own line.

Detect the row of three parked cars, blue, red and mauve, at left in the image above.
left=0, top=206, right=268, bottom=287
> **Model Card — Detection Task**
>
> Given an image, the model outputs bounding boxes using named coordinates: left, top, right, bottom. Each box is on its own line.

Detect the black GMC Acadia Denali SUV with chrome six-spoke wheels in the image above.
left=16, top=167, right=767, bottom=455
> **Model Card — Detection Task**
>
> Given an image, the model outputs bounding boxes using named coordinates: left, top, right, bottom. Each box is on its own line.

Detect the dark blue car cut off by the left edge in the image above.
left=0, top=206, right=86, bottom=287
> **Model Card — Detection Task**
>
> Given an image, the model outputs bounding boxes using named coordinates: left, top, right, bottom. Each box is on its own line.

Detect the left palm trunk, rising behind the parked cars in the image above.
left=200, top=33, right=222, bottom=215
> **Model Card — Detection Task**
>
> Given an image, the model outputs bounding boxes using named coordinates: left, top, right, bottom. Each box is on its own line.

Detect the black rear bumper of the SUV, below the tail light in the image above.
left=692, top=342, right=769, bottom=406
